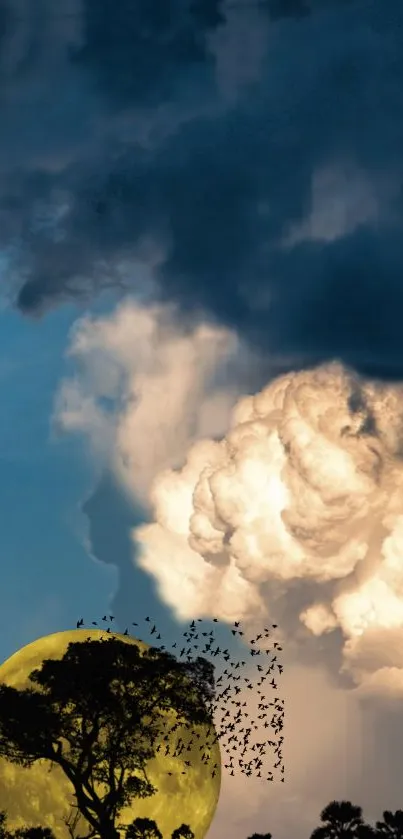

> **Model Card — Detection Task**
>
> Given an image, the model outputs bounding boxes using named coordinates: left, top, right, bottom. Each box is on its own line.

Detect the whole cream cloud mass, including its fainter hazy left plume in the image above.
left=56, top=302, right=403, bottom=694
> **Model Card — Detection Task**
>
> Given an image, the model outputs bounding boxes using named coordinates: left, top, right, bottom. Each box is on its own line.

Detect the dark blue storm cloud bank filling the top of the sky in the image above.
left=0, top=0, right=403, bottom=378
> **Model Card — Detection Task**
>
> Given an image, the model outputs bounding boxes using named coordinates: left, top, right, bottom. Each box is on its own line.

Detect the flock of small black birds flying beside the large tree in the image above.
left=77, top=615, right=284, bottom=783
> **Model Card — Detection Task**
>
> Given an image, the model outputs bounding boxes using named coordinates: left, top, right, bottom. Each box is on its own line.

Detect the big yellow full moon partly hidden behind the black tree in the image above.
left=0, top=629, right=221, bottom=839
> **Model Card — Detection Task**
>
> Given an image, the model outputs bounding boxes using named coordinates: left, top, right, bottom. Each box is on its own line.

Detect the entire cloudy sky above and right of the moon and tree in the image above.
left=0, top=0, right=403, bottom=839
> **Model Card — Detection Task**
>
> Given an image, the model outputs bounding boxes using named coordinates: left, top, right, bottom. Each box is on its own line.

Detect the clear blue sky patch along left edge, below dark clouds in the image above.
left=0, top=298, right=116, bottom=660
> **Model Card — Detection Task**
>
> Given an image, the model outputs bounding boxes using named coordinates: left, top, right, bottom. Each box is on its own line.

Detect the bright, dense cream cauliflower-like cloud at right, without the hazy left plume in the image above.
left=134, top=363, right=403, bottom=692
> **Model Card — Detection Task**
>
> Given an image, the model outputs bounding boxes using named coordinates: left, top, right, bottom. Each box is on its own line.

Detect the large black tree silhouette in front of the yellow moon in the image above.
left=0, top=636, right=218, bottom=839
